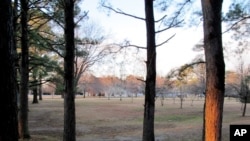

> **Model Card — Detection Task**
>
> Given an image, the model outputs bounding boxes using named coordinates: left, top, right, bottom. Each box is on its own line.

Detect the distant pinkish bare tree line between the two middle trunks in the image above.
left=78, top=74, right=143, bottom=100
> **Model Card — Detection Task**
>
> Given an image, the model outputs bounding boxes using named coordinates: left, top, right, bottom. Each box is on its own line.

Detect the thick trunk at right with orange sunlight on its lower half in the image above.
left=201, top=0, right=225, bottom=141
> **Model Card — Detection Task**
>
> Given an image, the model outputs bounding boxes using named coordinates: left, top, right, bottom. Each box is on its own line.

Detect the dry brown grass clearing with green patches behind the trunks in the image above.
left=20, top=96, right=250, bottom=141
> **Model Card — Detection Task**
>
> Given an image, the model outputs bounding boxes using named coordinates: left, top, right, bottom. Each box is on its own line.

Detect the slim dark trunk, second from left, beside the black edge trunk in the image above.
left=19, top=0, right=30, bottom=138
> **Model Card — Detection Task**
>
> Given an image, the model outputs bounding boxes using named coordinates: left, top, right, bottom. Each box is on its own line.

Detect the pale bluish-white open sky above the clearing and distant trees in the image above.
left=78, top=0, right=236, bottom=76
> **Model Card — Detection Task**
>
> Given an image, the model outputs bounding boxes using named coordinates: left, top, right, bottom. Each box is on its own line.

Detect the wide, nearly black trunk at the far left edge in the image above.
left=0, top=0, right=18, bottom=141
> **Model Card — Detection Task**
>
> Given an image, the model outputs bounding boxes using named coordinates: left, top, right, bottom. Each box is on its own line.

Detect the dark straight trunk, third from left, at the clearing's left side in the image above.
left=63, top=0, right=76, bottom=141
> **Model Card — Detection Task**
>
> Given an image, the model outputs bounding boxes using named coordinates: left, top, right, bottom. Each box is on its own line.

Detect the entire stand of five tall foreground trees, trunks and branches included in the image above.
left=0, top=0, right=250, bottom=141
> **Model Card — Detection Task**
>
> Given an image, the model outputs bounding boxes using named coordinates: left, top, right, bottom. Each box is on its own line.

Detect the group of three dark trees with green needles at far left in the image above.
left=0, top=0, right=110, bottom=140
